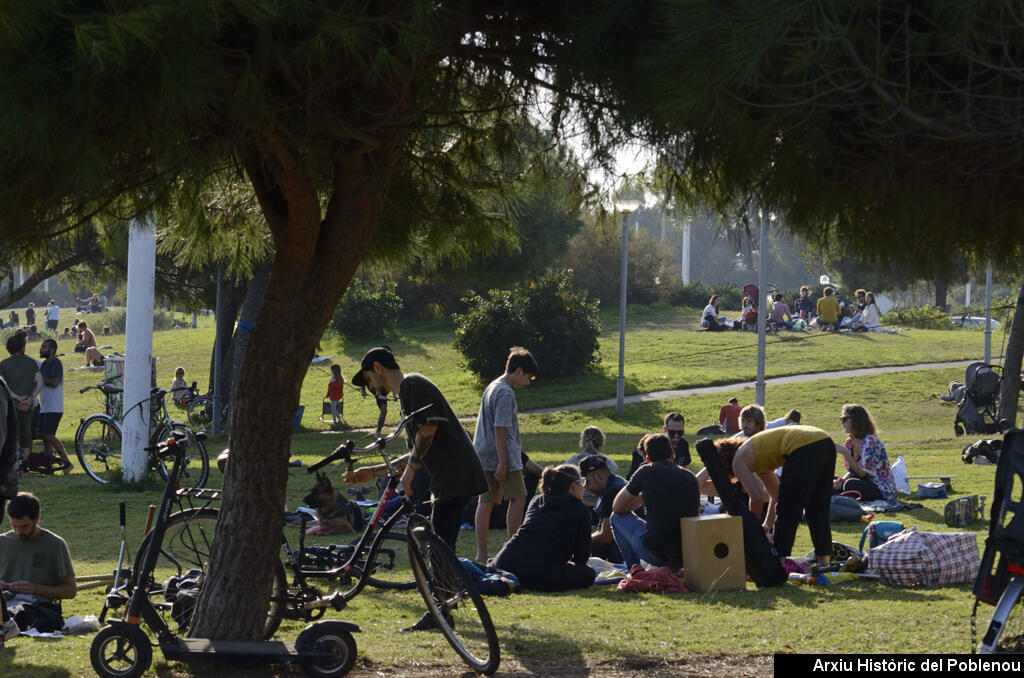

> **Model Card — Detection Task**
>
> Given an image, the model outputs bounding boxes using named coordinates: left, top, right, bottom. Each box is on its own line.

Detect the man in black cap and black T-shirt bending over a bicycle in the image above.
left=346, top=346, right=487, bottom=550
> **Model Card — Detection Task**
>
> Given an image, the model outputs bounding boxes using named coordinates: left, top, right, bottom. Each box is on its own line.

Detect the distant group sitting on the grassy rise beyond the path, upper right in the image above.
left=700, top=285, right=883, bottom=332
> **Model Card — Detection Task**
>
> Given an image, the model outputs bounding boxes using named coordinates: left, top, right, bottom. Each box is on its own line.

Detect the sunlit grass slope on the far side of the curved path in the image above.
left=34, top=306, right=1002, bottom=437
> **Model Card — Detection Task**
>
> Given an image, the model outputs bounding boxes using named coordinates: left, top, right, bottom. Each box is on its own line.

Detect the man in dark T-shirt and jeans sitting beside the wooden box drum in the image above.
left=611, top=433, right=700, bottom=568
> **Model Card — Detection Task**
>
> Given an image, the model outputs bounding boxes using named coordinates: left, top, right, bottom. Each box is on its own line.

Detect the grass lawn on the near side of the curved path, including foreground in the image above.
left=6, top=369, right=1022, bottom=677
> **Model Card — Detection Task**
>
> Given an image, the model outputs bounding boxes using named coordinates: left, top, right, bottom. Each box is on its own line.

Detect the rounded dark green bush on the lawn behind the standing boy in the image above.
left=455, top=270, right=601, bottom=380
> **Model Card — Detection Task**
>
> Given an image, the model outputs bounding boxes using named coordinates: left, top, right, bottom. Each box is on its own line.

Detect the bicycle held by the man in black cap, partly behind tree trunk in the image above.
left=119, top=411, right=501, bottom=675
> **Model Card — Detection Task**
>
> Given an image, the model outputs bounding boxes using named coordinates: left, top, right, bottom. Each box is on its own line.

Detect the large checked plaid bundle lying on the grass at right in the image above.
left=867, top=527, right=981, bottom=586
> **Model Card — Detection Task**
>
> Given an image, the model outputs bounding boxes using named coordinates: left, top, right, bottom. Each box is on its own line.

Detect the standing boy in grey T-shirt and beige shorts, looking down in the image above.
left=473, top=346, right=540, bottom=562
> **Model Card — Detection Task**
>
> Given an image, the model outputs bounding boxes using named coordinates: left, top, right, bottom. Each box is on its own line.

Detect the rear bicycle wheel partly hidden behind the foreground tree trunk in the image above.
left=132, top=507, right=288, bottom=639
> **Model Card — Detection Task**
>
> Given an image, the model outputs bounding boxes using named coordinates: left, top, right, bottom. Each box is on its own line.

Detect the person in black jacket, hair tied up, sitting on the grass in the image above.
left=494, top=464, right=596, bottom=591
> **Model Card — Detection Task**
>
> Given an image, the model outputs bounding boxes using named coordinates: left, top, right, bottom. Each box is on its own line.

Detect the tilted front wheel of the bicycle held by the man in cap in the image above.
left=409, top=525, right=501, bottom=676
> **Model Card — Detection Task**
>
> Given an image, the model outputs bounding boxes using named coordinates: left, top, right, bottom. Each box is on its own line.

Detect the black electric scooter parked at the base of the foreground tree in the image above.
left=89, top=432, right=359, bottom=678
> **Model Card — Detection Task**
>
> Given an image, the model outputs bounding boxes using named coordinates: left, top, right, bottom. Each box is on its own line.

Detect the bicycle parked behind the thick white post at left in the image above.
left=75, top=379, right=210, bottom=488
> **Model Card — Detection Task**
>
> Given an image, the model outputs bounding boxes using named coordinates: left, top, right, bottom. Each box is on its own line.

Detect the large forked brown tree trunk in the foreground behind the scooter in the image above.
left=189, top=130, right=404, bottom=639
